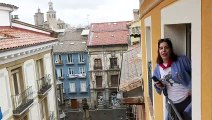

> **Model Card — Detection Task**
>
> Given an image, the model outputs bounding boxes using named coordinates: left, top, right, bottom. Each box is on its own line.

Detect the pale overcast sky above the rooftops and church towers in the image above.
left=0, top=0, right=139, bottom=26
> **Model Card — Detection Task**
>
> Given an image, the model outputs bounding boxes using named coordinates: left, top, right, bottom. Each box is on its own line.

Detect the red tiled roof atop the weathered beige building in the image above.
left=87, top=21, right=129, bottom=46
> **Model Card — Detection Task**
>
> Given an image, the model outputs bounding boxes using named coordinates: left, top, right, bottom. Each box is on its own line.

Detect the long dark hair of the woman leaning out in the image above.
left=156, top=38, right=178, bottom=64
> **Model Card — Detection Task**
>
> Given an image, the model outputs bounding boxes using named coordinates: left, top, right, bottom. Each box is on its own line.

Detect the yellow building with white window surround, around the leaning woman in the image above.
left=140, top=0, right=212, bottom=120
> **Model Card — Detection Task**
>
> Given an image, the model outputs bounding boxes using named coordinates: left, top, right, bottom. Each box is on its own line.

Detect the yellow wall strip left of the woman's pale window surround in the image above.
left=141, top=0, right=176, bottom=120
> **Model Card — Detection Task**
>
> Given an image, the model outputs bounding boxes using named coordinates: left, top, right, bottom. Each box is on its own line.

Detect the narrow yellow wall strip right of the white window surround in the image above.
left=201, top=0, right=212, bottom=120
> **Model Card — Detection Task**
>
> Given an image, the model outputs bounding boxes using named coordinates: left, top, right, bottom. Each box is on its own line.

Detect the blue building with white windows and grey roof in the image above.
left=53, top=28, right=90, bottom=109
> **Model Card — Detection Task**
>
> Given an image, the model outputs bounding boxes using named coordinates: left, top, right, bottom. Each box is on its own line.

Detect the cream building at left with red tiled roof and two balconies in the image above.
left=0, top=3, right=58, bottom=120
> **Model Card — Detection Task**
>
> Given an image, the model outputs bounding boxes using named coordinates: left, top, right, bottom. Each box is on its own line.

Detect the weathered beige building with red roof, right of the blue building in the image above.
left=87, top=21, right=129, bottom=108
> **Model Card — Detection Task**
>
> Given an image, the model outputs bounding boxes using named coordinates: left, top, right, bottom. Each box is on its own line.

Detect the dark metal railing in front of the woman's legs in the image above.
left=166, top=97, right=183, bottom=120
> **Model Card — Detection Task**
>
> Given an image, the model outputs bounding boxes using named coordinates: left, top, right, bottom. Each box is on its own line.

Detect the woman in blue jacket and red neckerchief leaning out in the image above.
left=154, top=38, right=191, bottom=120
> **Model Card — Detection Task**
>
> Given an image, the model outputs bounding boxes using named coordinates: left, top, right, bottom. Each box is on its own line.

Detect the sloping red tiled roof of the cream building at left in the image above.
left=0, top=27, right=57, bottom=50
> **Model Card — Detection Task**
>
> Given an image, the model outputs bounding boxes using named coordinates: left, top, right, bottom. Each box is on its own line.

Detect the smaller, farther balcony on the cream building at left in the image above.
left=37, top=76, right=51, bottom=96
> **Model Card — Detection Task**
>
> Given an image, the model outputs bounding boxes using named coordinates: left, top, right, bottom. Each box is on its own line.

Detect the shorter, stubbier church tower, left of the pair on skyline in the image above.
left=34, top=8, right=44, bottom=27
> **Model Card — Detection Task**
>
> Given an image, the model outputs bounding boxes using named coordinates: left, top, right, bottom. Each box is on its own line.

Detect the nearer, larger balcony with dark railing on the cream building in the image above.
left=12, top=86, right=33, bottom=116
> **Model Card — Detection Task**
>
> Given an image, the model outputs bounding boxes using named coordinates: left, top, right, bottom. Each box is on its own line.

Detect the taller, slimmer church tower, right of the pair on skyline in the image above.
left=47, top=1, right=57, bottom=29
